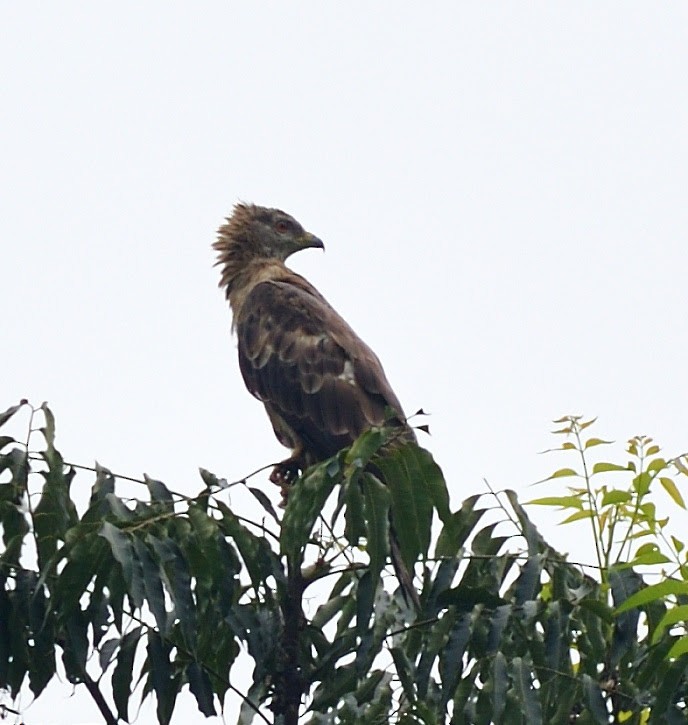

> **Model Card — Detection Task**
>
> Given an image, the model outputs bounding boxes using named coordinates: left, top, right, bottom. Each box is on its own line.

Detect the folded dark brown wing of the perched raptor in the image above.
left=237, top=274, right=405, bottom=460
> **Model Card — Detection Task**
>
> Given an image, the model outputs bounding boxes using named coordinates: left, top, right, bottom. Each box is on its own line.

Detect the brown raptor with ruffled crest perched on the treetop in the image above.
left=213, top=204, right=415, bottom=493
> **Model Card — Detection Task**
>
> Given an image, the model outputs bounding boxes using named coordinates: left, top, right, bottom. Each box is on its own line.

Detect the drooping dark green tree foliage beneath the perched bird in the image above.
left=0, top=401, right=688, bottom=725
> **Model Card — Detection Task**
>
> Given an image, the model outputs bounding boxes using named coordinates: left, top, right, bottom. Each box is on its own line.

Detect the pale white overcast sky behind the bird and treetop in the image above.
left=0, top=0, right=688, bottom=725
